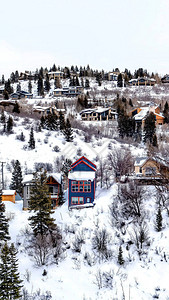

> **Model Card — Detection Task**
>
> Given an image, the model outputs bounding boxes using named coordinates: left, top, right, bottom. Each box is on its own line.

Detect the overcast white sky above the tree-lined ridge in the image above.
left=0, top=0, right=169, bottom=76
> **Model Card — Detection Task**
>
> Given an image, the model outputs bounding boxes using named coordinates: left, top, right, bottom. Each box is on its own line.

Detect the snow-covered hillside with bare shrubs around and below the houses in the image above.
left=0, top=77, right=169, bottom=300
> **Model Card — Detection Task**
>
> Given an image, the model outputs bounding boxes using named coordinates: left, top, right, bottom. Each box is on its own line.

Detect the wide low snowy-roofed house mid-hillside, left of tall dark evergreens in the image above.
left=80, top=107, right=118, bottom=121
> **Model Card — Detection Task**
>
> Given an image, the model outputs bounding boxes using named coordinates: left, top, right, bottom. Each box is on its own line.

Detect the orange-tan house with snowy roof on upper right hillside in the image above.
left=129, top=105, right=164, bottom=129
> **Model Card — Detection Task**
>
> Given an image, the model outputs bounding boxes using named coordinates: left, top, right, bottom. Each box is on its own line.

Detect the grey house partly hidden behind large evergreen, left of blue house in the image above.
left=23, top=173, right=62, bottom=210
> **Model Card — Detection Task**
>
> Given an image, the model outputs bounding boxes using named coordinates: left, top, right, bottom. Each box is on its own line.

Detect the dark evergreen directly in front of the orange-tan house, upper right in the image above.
left=143, top=113, right=156, bottom=144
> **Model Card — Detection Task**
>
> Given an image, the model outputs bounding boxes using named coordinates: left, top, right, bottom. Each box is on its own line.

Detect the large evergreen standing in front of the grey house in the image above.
left=29, top=172, right=56, bottom=237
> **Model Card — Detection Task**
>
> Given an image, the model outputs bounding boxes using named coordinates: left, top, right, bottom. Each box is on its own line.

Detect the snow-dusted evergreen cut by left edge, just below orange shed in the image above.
left=0, top=190, right=10, bottom=246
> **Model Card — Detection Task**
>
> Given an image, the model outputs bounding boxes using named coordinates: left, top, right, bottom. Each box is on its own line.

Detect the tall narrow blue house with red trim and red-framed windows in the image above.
left=68, top=156, right=96, bottom=209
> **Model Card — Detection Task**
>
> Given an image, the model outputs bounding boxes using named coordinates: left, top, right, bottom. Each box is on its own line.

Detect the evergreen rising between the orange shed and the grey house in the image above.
left=10, top=160, right=23, bottom=195
